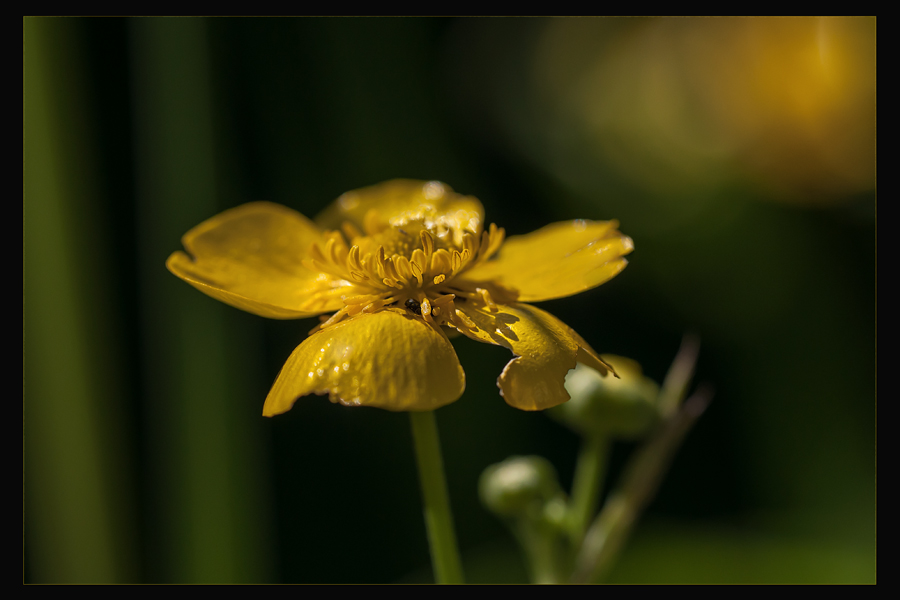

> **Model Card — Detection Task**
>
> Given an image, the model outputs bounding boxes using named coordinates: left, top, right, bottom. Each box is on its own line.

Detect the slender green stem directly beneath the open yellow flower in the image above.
left=409, top=410, right=463, bottom=583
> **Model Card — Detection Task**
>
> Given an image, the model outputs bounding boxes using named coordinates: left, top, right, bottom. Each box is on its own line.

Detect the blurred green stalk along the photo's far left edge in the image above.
left=22, top=17, right=138, bottom=583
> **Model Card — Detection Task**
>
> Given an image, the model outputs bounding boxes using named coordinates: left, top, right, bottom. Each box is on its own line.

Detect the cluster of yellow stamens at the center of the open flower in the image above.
left=304, top=213, right=515, bottom=333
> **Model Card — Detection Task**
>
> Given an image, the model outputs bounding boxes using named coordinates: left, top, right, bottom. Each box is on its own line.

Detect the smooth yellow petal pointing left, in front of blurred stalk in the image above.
left=166, top=202, right=346, bottom=319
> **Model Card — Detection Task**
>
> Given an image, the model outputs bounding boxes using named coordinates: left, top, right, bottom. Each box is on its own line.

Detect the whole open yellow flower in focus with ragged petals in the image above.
left=166, top=180, right=633, bottom=416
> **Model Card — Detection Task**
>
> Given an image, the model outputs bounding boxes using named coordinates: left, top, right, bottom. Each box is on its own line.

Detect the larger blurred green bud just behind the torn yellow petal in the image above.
left=549, top=354, right=661, bottom=439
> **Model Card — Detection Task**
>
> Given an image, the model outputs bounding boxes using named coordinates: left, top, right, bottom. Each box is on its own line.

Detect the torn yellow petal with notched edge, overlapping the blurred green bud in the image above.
left=461, top=303, right=606, bottom=410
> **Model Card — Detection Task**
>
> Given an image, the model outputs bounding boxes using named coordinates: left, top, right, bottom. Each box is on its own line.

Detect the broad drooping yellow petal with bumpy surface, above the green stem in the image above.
left=263, top=309, right=466, bottom=417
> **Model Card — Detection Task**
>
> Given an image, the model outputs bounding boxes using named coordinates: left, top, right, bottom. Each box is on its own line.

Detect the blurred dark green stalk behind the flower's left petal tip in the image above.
left=130, top=18, right=272, bottom=583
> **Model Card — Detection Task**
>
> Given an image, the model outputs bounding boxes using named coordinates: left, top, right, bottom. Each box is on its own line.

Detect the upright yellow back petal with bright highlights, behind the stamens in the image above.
left=316, top=179, right=484, bottom=235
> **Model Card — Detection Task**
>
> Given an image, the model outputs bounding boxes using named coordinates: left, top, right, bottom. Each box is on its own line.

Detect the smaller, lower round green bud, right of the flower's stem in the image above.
left=478, top=456, right=562, bottom=519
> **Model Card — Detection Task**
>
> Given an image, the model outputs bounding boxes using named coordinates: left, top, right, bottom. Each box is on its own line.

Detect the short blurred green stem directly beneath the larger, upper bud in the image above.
left=568, top=435, right=610, bottom=548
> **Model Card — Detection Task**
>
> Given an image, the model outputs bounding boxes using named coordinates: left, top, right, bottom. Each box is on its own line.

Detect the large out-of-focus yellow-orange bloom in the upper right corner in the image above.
left=478, top=17, right=877, bottom=204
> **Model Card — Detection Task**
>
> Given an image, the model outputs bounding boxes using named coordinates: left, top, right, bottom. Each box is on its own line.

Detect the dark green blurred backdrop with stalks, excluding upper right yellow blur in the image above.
left=23, top=18, right=876, bottom=583
